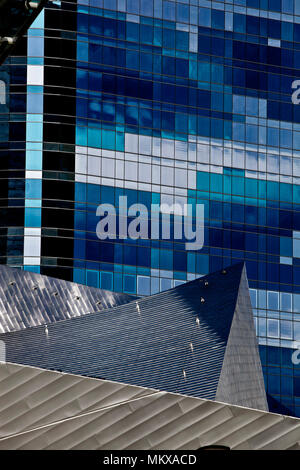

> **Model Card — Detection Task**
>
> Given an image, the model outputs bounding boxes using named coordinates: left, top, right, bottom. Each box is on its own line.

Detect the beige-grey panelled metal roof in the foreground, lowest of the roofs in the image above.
left=0, top=363, right=300, bottom=450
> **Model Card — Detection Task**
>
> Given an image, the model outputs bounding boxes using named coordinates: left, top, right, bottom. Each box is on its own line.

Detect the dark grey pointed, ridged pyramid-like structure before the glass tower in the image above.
left=0, top=264, right=268, bottom=410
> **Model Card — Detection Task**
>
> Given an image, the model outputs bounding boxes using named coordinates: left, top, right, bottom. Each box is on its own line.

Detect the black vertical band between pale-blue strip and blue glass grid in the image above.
left=41, top=1, right=77, bottom=280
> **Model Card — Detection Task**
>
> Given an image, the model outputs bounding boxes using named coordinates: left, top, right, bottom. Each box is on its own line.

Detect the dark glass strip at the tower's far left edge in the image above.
left=0, top=38, right=27, bottom=266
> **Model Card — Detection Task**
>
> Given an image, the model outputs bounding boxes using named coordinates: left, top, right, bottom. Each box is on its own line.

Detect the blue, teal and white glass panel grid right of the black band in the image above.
left=75, top=1, right=300, bottom=415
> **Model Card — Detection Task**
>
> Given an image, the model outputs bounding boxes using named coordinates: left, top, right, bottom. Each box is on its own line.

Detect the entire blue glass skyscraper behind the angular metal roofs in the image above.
left=0, top=0, right=300, bottom=416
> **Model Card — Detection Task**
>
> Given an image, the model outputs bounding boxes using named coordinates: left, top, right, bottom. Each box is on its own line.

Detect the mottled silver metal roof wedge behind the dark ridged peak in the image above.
left=0, top=265, right=136, bottom=333
